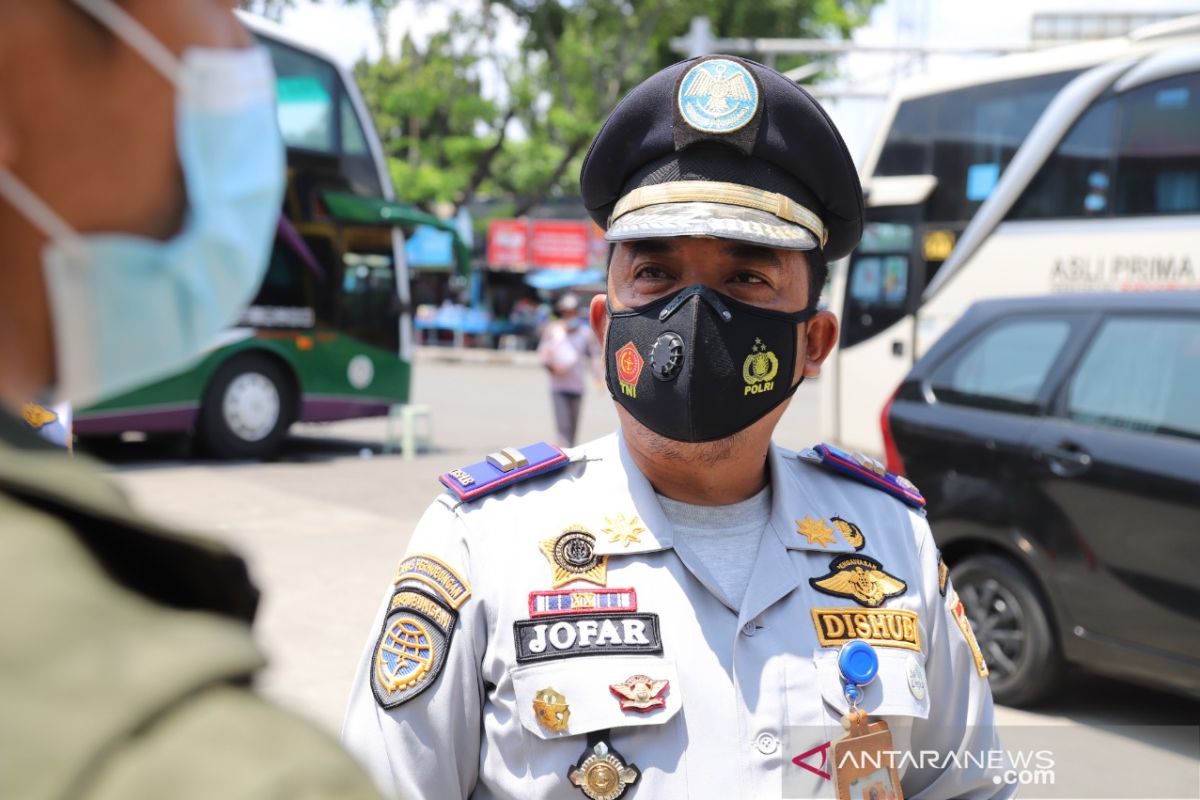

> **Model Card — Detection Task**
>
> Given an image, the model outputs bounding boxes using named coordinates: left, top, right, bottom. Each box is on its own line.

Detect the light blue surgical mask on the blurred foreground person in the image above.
left=0, top=0, right=284, bottom=404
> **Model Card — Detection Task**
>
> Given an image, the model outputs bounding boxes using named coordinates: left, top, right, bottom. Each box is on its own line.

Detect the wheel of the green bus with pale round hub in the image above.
left=199, top=353, right=295, bottom=458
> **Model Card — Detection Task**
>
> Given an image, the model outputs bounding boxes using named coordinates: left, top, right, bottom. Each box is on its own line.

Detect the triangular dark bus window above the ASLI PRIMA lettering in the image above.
left=1008, top=97, right=1117, bottom=219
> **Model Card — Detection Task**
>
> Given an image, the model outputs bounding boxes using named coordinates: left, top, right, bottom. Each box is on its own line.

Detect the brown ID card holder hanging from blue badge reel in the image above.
left=833, top=709, right=904, bottom=800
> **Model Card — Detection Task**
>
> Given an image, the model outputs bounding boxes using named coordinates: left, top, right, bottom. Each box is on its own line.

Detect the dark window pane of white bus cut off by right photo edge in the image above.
left=1115, top=73, right=1200, bottom=216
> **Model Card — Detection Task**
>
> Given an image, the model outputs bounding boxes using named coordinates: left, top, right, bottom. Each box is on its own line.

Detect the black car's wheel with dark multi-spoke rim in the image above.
left=950, top=554, right=1062, bottom=705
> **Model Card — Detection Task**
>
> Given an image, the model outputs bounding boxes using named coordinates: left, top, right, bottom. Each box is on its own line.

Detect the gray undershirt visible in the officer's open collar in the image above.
left=658, top=486, right=770, bottom=609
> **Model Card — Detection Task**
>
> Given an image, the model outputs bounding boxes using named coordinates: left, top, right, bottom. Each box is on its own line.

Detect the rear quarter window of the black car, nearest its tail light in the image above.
left=930, top=317, right=1072, bottom=413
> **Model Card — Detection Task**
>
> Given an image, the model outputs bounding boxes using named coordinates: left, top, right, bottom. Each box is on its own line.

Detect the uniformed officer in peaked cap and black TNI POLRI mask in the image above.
left=343, top=55, right=1010, bottom=800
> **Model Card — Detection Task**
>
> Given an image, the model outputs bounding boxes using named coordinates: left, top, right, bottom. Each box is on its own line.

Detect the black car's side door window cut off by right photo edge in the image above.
left=1067, top=317, right=1200, bottom=439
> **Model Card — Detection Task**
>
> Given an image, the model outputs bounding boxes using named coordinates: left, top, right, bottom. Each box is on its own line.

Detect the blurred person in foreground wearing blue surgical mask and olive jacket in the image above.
left=0, top=0, right=377, bottom=800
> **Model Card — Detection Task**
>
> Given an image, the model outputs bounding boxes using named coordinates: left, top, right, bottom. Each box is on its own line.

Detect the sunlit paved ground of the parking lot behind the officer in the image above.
left=104, top=356, right=1200, bottom=798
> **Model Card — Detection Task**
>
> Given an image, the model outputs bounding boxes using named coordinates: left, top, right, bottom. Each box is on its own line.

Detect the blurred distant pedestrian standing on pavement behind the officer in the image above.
left=538, top=294, right=601, bottom=447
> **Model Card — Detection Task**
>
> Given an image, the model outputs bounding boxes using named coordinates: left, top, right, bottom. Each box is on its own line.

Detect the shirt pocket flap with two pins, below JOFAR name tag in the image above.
left=510, top=656, right=683, bottom=740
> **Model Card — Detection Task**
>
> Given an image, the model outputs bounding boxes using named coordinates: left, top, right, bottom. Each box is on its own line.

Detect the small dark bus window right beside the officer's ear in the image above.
left=842, top=222, right=913, bottom=347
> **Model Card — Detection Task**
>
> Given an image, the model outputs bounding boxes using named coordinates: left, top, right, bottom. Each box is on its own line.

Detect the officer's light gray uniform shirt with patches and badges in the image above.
left=343, top=435, right=1012, bottom=800
